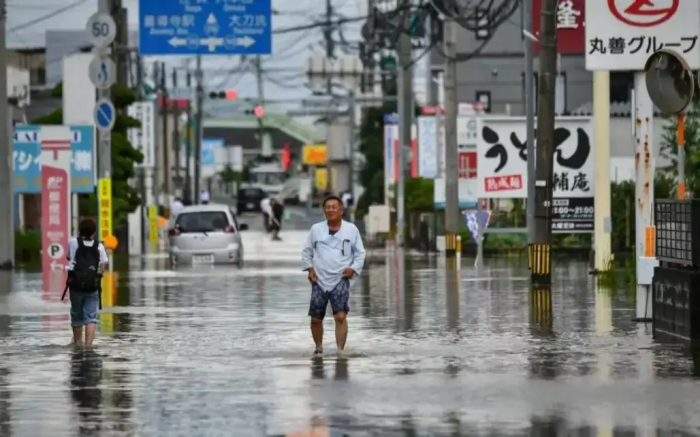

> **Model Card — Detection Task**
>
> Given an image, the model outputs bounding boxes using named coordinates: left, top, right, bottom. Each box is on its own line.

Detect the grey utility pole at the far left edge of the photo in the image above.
left=0, top=0, right=15, bottom=270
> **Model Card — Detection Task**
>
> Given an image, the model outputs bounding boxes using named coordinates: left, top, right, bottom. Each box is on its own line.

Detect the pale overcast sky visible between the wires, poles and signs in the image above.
left=7, top=0, right=367, bottom=116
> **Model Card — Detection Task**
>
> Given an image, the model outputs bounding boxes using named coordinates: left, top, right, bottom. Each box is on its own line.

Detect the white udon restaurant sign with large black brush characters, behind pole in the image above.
left=477, top=117, right=595, bottom=199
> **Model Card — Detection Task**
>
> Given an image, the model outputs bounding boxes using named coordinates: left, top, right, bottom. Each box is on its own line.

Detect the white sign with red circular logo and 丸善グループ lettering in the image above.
left=585, top=0, right=700, bottom=71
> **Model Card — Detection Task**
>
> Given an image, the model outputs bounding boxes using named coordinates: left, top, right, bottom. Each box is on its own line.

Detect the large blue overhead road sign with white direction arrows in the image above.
left=139, top=0, right=272, bottom=55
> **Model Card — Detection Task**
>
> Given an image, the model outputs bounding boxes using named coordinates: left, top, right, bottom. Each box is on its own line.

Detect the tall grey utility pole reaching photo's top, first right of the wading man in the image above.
left=396, top=0, right=413, bottom=247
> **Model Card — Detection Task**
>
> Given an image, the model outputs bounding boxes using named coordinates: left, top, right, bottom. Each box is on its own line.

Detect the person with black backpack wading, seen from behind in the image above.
left=64, top=219, right=109, bottom=347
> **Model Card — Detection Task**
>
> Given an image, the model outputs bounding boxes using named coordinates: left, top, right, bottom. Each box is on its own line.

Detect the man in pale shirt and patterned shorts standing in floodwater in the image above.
left=301, top=196, right=365, bottom=356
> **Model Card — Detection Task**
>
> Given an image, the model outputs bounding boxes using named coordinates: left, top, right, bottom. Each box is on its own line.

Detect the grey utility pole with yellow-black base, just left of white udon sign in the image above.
left=443, top=17, right=460, bottom=258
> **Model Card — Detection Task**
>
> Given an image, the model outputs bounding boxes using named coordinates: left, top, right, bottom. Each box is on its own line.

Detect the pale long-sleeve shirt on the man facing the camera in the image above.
left=301, top=220, right=365, bottom=291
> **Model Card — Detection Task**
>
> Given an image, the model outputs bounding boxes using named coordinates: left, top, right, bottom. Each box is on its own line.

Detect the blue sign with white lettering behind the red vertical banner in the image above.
left=12, top=125, right=96, bottom=194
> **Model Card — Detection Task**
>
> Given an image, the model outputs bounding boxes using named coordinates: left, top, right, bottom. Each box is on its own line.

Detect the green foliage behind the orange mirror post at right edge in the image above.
left=655, top=102, right=700, bottom=197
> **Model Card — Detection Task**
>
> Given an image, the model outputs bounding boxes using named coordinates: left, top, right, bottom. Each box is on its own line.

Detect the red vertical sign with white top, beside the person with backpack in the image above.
left=39, top=126, right=72, bottom=301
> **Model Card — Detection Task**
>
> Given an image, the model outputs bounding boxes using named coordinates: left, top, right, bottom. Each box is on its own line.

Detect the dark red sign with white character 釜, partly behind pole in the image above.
left=532, top=0, right=584, bottom=55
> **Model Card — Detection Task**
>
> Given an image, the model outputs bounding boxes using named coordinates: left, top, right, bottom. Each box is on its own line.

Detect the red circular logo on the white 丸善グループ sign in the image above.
left=608, top=0, right=680, bottom=27
